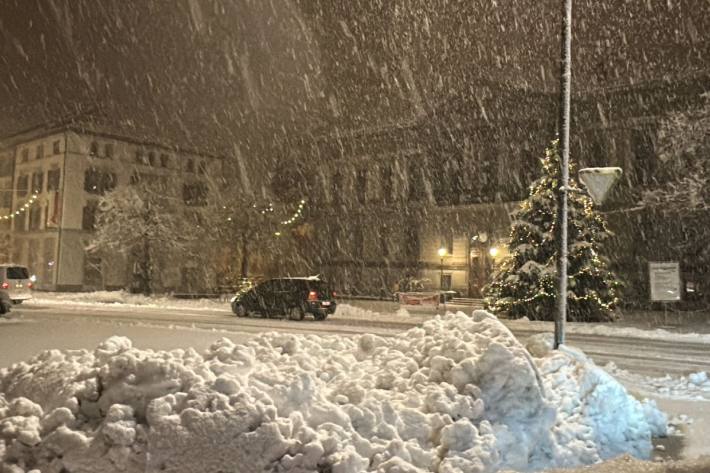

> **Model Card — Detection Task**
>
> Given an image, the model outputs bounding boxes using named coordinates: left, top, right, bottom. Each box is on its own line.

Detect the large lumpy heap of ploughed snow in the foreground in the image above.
left=0, top=311, right=665, bottom=473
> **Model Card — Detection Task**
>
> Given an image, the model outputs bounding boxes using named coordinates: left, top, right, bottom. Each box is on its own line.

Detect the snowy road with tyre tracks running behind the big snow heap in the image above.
left=5, top=303, right=710, bottom=376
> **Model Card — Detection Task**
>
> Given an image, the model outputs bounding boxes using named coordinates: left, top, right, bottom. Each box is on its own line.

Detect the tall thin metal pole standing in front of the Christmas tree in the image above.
left=554, top=0, right=572, bottom=349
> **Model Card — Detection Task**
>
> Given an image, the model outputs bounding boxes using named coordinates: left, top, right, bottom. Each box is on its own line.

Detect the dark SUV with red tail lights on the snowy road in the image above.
left=232, top=277, right=336, bottom=320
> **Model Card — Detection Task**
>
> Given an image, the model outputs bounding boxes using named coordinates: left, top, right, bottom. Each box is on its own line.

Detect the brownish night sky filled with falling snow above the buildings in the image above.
left=0, top=0, right=710, bottom=159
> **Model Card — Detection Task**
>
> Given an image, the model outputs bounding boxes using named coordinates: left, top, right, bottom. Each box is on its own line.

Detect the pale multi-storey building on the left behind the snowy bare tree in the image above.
left=0, top=125, right=224, bottom=290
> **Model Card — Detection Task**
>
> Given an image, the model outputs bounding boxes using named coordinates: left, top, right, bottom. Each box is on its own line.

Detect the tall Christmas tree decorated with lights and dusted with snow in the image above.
left=485, top=140, right=621, bottom=321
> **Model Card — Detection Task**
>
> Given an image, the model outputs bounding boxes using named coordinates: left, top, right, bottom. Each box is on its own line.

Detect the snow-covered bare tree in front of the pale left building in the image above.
left=88, top=184, right=197, bottom=295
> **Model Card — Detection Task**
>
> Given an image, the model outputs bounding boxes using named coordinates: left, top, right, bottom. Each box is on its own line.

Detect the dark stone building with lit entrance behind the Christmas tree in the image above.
left=290, top=74, right=710, bottom=300
